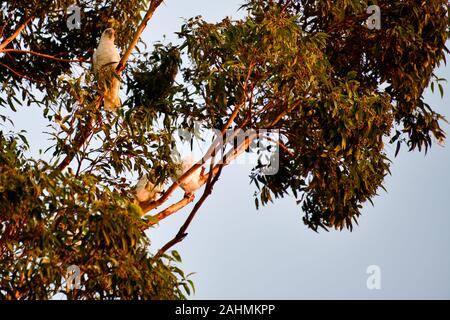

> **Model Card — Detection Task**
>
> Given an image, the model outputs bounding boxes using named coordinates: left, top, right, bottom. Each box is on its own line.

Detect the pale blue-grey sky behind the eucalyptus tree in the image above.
left=4, top=0, right=450, bottom=299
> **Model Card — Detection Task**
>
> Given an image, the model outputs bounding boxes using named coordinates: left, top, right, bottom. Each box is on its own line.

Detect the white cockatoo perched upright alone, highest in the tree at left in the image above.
left=92, top=28, right=120, bottom=111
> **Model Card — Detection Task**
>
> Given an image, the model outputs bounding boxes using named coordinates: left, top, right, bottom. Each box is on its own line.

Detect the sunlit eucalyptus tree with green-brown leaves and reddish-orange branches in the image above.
left=0, top=0, right=449, bottom=299
